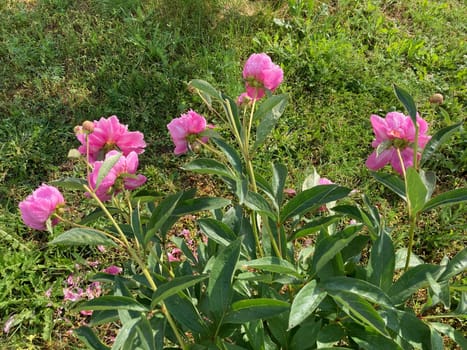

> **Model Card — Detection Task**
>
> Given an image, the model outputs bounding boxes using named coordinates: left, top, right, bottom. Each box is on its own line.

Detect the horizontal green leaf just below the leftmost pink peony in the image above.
left=49, top=228, right=116, bottom=246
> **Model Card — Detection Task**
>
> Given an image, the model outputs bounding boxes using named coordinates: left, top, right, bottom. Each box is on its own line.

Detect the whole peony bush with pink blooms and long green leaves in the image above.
left=18, top=53, right=467, bottom=350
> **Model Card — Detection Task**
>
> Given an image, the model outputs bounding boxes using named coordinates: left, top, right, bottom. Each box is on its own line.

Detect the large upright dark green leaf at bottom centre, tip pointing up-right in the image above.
left=207, top=237, right=242, bottom=320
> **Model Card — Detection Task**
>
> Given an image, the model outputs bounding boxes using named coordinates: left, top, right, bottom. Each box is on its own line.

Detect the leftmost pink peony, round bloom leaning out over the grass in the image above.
left=19, top=184, right=65, bottom=230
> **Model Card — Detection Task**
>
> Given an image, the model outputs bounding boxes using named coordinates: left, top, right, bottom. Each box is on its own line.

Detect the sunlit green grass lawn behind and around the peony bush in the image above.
left=0, top=0, right=467, bottom=348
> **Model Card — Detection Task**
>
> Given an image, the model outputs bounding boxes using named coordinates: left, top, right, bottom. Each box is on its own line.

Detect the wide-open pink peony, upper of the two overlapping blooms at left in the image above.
left=75, top=115, right=146, bottom=163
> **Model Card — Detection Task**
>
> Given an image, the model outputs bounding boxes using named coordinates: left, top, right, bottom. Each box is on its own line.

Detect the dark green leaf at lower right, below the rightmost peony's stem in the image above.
left=387, top=264, right=440, bottom=305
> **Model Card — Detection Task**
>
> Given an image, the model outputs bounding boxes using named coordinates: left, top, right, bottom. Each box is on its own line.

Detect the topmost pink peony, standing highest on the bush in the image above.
left=243, top=53, right=284, bottom=99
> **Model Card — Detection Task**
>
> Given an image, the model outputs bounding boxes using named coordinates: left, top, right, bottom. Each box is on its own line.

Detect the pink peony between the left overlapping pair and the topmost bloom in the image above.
left=167, top=110, right=212, bottom=155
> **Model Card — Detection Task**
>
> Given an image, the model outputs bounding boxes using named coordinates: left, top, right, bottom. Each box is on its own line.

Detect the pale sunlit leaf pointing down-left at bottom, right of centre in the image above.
left=288, top=280, right=327, bottom=330
